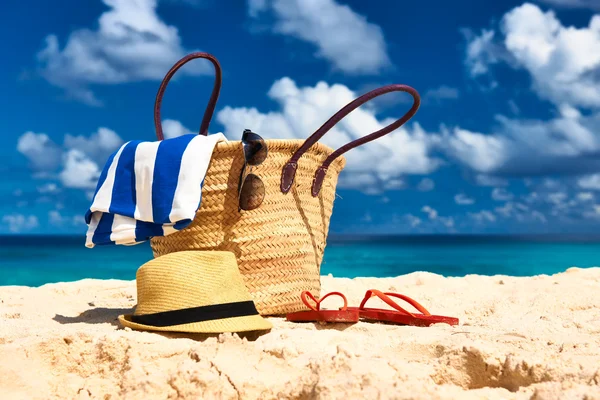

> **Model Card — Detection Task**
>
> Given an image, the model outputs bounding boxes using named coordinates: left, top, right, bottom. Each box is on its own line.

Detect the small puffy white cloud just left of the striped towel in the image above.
left=59, top=150, right=100, bottom=189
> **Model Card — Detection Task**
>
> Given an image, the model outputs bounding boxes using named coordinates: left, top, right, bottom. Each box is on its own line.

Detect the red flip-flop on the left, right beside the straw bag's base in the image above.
left=286, top=291, right=358, bottom=323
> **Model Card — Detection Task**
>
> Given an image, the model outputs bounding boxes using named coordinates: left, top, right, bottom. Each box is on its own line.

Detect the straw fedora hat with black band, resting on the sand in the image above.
left=119, top=251, right=273, bottom=333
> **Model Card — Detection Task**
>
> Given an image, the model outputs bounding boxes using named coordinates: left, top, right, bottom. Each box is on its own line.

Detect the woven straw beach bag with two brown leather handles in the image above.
left=151, top=53, right=420, bottom=315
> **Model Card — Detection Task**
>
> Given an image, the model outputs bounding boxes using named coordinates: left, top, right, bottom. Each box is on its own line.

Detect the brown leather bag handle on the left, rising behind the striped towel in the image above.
left=154, top=52, right=221, bottom=140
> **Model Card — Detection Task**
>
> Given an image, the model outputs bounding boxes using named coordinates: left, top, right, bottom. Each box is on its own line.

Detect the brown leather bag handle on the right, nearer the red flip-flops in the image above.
left=281, top=84, right=421, bottom=197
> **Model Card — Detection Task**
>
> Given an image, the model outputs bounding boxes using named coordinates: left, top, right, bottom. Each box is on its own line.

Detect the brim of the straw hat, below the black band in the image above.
left=119, top=314, right=273, bottom=333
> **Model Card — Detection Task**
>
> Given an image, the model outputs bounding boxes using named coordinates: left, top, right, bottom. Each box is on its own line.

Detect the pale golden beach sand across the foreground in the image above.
left=0, top=268, right=600, bottom=400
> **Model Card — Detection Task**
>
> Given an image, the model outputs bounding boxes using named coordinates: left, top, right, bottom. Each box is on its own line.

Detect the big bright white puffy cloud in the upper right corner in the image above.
left=465, top=3, right=600, bottom=107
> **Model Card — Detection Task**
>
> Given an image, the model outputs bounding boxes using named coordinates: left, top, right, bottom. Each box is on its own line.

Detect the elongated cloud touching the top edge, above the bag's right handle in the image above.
left=248, top=0, right=390, bottom=74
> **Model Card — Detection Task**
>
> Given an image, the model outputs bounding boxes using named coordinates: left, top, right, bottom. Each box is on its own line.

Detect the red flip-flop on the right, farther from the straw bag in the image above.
left=348, top=289, right=458, bottom=326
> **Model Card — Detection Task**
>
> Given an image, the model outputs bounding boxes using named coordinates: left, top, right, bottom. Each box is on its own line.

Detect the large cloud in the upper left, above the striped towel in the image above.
left=37, top=0, right=210, bottom=105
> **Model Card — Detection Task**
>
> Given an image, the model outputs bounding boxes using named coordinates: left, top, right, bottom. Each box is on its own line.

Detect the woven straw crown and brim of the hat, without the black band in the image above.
left=119, top=251, right=272, bottom=333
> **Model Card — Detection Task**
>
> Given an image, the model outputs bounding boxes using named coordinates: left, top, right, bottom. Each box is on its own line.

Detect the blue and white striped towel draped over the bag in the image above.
left=85, top=133, right=226, bottom=248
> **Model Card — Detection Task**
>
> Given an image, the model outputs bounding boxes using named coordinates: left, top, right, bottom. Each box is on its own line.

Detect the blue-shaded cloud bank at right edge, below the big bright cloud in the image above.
left=440, top=105, right=600, bottom=176
